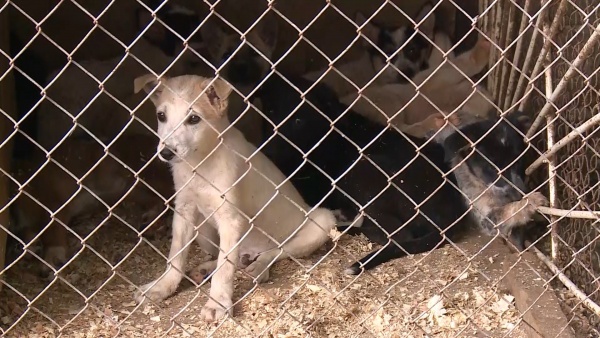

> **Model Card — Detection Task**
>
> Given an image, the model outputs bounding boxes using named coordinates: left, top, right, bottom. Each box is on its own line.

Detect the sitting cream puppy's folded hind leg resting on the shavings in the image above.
left=245, top=208, right=336, bottom=283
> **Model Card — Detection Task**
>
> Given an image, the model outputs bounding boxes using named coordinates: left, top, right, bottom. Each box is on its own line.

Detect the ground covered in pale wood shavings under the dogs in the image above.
left=0, top=207, right=540, bottom=338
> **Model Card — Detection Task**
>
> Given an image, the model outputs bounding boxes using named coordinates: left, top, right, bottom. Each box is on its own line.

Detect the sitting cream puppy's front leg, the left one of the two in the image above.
left=134, top=201, right=199, bottom=303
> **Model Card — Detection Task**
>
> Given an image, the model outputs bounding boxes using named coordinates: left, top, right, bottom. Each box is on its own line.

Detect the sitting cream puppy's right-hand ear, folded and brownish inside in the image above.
left=194, top=79, right=233, bottom=118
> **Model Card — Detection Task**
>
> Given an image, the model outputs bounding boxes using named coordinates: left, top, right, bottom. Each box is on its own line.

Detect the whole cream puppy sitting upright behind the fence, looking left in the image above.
left=135, top=75, right=336, bottom=321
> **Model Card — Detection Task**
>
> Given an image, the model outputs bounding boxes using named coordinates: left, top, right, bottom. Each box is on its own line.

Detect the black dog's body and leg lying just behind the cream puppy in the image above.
left=257, top=75, right=467, bottom=274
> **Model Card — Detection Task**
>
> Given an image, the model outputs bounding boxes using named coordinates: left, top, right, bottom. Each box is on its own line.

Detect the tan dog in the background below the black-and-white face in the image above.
left=341, top=32, right=494, bottom=137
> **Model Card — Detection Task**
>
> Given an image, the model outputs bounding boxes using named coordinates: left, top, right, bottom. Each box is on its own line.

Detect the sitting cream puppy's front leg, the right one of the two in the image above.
left=200, top=205, right=247, bottom=322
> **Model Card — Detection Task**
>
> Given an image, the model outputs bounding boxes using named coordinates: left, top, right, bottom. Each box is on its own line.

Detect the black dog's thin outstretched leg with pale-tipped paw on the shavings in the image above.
left=344, top=231, right=446, bottom=275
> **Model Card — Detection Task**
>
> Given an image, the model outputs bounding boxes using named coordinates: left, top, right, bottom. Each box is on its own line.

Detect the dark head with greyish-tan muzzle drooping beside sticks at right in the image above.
left=436, top=112, right=548, bottom=250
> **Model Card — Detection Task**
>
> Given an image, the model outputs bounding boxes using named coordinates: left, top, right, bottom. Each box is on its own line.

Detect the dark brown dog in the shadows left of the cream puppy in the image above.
left=11, top=135, right=174, bottom=271
